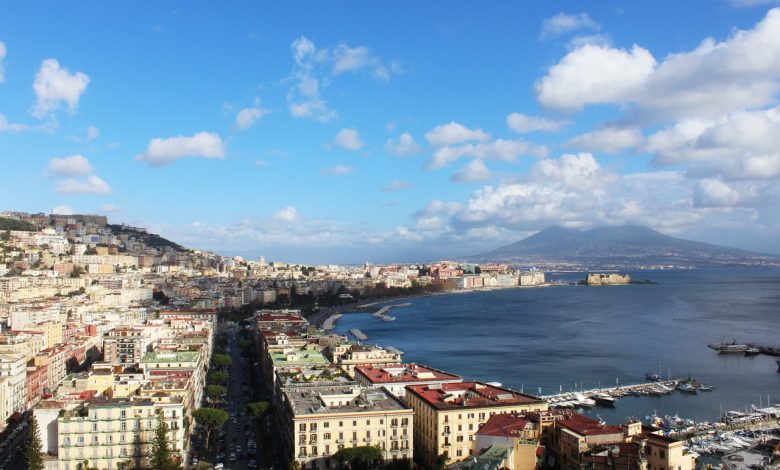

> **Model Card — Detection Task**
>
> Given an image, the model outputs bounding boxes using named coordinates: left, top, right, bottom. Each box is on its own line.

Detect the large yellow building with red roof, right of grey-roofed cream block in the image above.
left=406, top=382, right=547, bottom=467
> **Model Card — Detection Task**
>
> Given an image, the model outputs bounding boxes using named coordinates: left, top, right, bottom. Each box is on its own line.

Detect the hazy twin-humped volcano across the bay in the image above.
left=469, top=225, right=780, bottom=268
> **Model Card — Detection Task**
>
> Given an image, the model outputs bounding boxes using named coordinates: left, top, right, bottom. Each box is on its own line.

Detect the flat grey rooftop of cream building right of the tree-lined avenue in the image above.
left=284, top=385, right=411, bottom=416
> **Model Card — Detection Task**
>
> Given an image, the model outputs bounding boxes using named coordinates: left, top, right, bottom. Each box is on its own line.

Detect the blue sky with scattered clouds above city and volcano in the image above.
left=0, top=0, right=780, bottom=263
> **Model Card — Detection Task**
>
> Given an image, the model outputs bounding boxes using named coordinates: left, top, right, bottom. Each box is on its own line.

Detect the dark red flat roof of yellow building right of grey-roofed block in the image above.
left=406, top=382, right=546, bottom=410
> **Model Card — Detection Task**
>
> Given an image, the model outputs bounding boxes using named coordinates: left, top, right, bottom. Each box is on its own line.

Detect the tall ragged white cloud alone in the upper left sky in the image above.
left=32, top=59, right=89, bottom=118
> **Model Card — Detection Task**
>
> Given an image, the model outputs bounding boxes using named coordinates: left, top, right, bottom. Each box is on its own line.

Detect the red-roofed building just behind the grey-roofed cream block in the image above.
left=354, top=364, right=463, bottom=398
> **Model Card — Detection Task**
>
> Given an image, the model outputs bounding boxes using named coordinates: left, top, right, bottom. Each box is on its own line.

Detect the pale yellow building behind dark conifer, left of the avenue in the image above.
left=57, top=397, right=184, bottom=470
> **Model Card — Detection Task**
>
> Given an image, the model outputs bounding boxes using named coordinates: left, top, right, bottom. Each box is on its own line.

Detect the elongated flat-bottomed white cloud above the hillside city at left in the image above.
left=135, top=132, right=225, bottom=166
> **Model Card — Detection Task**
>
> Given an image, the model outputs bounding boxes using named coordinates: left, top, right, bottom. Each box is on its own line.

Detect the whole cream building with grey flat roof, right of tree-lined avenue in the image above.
left=281, top=385, right=414, bottom=469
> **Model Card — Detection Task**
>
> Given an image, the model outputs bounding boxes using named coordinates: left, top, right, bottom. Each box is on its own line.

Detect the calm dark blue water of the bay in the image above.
left=336, top=269, right=780, bottom=423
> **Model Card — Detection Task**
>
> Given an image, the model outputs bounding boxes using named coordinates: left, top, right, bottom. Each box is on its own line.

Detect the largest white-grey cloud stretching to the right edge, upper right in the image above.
left=536, top=8, right=780, bottom=119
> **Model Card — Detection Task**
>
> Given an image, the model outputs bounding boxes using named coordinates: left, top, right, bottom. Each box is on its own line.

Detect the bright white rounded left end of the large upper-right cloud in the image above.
left=536, top=44, right=655, bottom=111
